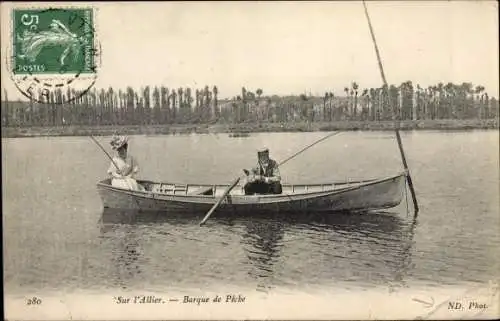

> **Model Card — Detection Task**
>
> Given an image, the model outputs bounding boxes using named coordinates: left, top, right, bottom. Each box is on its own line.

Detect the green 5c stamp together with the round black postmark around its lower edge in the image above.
left=7, top=7, right=101, bottom=103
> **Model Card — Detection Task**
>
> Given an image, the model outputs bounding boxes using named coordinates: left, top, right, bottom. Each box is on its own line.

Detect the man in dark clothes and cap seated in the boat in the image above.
left=244, top=148, right=282, bottom=195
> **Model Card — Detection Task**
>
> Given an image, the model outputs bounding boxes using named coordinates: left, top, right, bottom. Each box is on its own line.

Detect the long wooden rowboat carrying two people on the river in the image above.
left=97, top=172, right=407, bottom=215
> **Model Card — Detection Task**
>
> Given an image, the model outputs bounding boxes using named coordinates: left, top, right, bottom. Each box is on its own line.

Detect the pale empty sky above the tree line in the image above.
left=1, top=1, right=499, bottom=99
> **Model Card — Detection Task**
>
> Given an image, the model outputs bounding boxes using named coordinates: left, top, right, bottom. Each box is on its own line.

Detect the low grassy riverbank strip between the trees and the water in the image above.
left=2, top=119, right=498, bottom=138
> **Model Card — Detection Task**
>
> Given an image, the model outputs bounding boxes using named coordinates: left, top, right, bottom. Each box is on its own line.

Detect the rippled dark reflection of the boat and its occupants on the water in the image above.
left=97, top=210, right=417, bottom=292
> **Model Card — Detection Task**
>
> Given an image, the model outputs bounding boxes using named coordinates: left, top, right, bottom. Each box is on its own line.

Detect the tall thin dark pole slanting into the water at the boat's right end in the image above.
left=363, top=1, right=418, bottom=217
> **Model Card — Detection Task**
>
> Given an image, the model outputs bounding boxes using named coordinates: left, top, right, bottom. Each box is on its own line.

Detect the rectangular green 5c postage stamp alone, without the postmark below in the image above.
left=12, top=8, right=96, bottom=75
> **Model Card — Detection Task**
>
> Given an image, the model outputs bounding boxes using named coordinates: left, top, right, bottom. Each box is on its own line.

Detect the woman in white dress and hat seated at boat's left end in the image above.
left=108, top=136, right=144, bottom=191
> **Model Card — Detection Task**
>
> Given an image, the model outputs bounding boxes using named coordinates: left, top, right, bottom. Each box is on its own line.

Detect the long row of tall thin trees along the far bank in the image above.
left=2, top=81, right=499, bottom=127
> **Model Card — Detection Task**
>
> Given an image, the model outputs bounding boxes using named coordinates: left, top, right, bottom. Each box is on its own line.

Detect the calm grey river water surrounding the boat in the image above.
left=2, top=131, right=500, bottom=294
